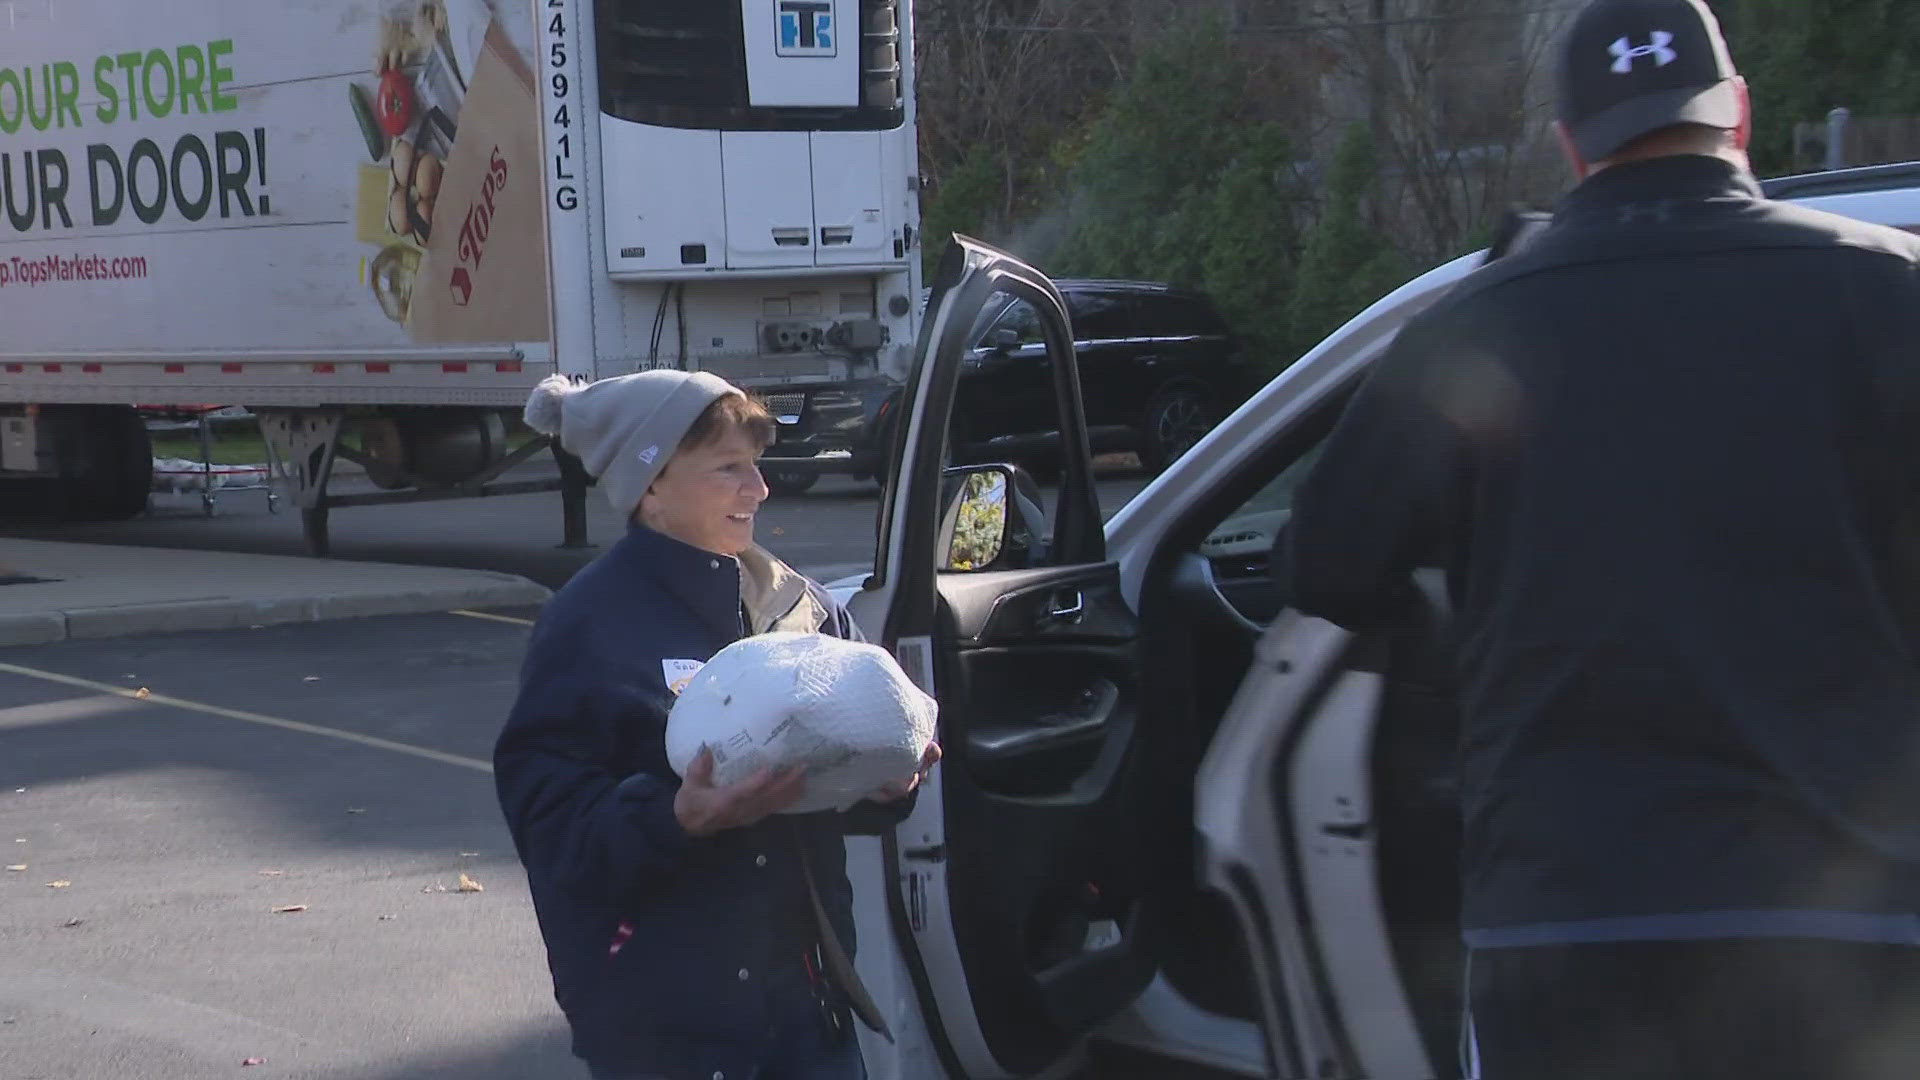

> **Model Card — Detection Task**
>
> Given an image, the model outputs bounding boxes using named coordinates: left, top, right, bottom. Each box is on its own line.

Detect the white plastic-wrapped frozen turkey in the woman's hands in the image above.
left=666, top=632, right=939, bottom=813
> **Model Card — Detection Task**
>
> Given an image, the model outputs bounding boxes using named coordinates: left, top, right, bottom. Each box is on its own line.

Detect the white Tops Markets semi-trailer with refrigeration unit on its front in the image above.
left=0, top=0, right=918, bottom=550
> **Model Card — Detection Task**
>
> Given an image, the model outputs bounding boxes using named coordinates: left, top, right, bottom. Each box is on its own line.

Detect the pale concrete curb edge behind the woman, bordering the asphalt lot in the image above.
left=0, top=575, right=553, bottom=646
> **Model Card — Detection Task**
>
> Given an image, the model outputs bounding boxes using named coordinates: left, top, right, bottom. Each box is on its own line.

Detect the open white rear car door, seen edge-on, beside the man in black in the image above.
left=1194, top=611, right=1465, bottom=1080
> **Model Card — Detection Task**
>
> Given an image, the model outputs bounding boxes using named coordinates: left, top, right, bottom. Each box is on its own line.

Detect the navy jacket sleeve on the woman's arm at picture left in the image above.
left=493, top=618, right=691, bottom=899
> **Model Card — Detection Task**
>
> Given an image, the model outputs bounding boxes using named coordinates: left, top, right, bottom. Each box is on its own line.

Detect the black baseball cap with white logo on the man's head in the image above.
left=1559, top=0, right=1741, bottom=161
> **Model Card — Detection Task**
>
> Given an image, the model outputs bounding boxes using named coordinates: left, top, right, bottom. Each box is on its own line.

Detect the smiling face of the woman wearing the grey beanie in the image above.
left=639, top=427, right=766, bottom=555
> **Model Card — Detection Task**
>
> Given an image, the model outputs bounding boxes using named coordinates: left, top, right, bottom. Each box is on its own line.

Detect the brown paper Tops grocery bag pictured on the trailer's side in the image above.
left=407, top=21, right=549, bottom=342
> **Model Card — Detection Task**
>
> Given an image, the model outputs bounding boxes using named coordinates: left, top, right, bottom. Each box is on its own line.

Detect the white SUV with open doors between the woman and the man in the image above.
left=843, top=163, right=1920, bottom=1080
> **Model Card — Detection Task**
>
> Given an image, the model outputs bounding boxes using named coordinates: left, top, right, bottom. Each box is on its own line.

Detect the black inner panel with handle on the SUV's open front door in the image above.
left=935, top=565, right=1152, bottom=1072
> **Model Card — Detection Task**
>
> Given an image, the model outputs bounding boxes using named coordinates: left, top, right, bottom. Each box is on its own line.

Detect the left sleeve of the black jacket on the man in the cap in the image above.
left=1275, top=309, right=1469, bottom=630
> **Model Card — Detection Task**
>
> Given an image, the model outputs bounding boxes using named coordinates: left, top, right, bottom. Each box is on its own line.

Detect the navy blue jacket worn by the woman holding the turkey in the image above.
left=493, top=527, right=912, bottom=1080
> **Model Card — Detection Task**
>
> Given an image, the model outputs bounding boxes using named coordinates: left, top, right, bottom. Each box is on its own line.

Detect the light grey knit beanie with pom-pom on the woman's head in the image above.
left=524, top=367, right=743, bottom=513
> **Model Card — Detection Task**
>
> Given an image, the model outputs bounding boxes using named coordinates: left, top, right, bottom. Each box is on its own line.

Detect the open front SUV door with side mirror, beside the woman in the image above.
left=849, top=236, right=1185, bottom=1078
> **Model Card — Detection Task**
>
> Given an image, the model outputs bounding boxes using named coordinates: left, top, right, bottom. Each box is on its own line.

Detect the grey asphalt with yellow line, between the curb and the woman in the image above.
left=0, top=611, right=580, bottom=1080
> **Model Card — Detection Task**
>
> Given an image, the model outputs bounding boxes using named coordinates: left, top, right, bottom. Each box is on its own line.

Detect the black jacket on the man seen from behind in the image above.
left=1284, top=158, right=1920, bottom=945
